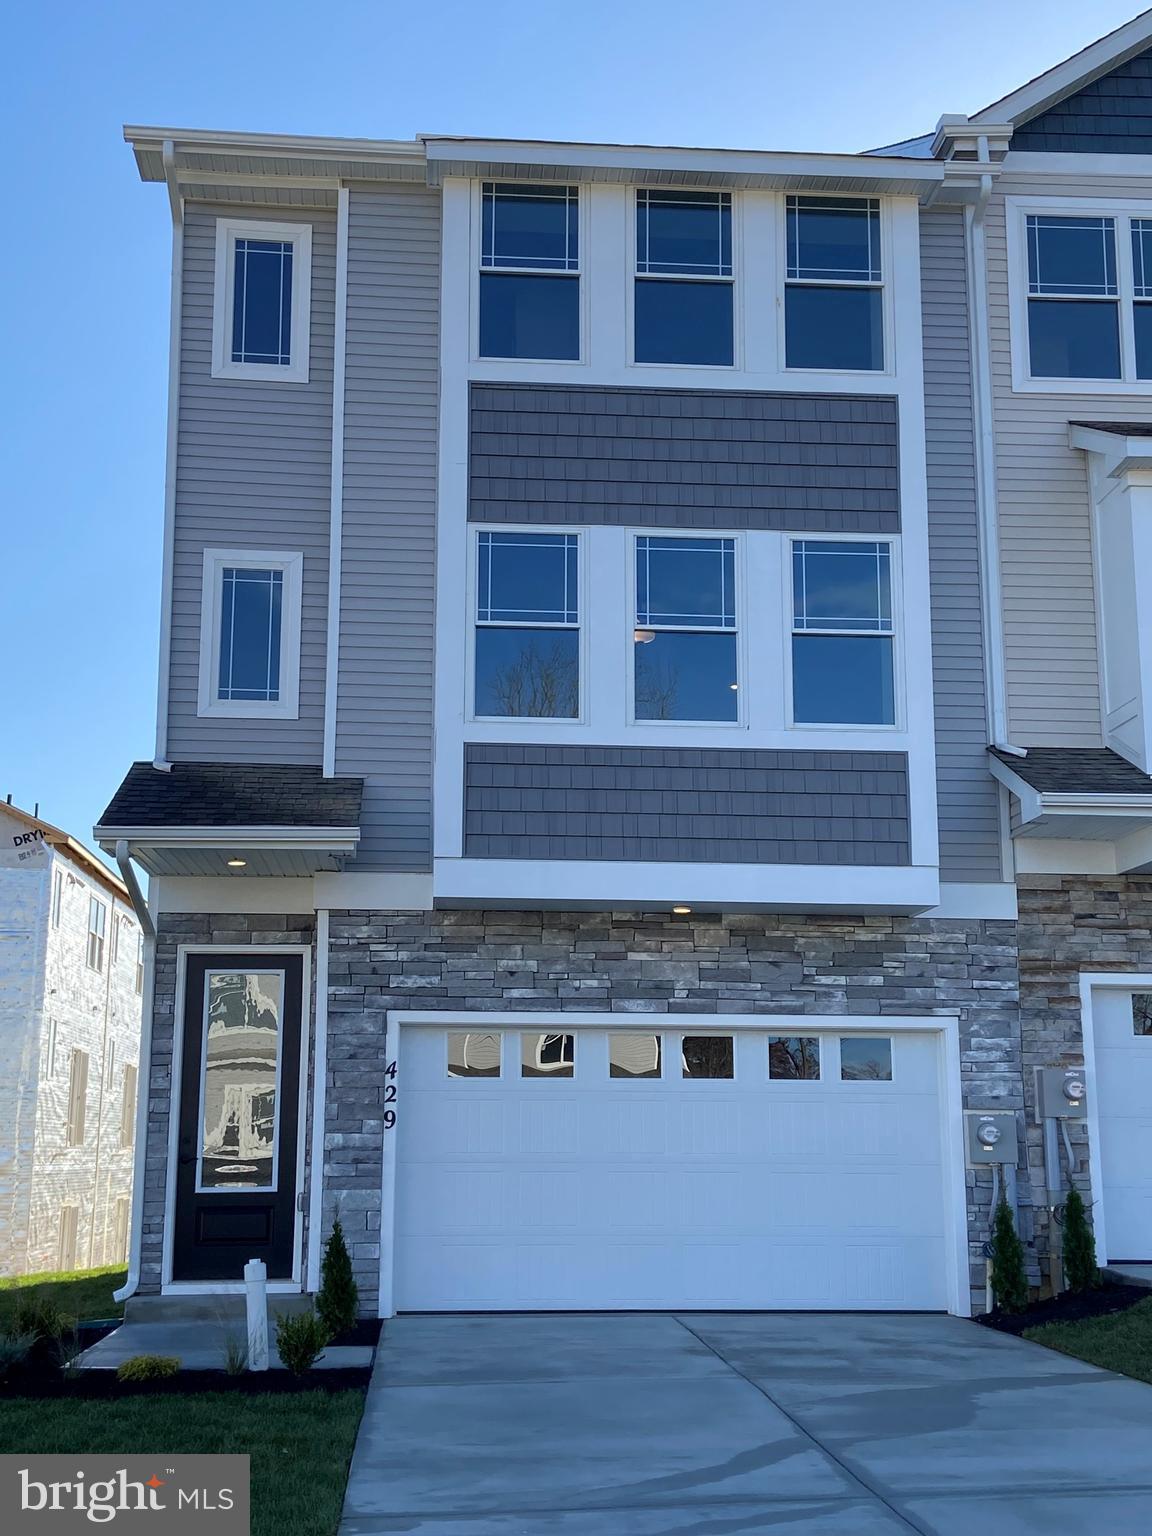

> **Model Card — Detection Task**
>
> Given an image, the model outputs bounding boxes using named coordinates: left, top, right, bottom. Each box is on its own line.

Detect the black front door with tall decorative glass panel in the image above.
left=172, top=949, right=304, bottom=1279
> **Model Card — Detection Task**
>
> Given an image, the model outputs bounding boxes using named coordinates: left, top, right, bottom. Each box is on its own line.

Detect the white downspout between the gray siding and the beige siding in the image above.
left=965, top=134, right=1023, bottom=756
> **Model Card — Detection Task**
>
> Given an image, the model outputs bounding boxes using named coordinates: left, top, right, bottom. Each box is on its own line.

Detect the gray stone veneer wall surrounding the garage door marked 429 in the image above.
left=324, top=911, right=1035, bottom=1307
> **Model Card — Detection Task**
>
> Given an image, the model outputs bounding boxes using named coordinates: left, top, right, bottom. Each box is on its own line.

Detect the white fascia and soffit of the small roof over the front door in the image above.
left=94, top=826, right=359, bottom=879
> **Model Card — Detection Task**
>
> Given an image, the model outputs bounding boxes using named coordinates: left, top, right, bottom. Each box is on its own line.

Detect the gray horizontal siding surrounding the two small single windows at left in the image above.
left=167, top=203, right=336, bottom=763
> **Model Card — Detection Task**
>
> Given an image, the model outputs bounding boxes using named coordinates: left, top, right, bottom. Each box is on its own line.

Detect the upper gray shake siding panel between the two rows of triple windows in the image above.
left=468, top=384, right=900, bottom=533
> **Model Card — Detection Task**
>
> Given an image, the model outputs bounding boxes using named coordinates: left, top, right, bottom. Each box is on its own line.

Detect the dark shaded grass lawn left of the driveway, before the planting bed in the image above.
left=0, top=1390, right=364, bottom=1536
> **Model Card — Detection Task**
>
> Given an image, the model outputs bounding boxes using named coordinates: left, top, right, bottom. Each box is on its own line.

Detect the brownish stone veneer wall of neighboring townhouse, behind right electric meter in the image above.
left=1017, top=874, right=1152, bottom=1246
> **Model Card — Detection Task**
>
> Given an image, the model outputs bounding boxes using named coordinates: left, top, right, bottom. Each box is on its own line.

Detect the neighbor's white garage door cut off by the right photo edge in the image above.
left=1092, top=988, right=1152, bottom=1264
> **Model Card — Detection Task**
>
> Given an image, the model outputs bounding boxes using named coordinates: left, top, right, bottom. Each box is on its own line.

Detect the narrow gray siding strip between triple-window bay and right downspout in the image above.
left=920, top=210, right=1001, bottom=882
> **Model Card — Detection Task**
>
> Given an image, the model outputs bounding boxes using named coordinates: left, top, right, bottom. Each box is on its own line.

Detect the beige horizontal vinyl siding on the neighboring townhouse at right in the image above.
left=986, top=169, right=1152, bottom=746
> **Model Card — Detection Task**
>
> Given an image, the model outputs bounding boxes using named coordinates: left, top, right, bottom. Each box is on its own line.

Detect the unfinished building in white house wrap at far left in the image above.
left=0, top=802, right=144, bottom=1276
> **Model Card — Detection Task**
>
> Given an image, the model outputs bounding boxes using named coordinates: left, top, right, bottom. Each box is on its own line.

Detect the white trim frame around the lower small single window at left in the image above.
left=197, top=550, right=304, bottom=720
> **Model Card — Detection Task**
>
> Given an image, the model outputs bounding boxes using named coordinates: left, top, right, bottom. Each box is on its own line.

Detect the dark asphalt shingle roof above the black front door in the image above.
left=98, top=762, right=364, bottom=826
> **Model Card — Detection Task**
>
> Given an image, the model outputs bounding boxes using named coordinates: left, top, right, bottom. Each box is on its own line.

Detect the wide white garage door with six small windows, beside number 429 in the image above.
left=395, top=1025, right=948, bottom=1310
